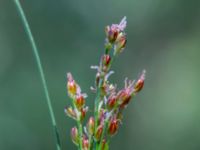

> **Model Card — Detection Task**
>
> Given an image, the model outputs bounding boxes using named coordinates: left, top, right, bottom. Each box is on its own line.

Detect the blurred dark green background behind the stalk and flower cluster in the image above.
left=0, top=0, right=200, bottom=150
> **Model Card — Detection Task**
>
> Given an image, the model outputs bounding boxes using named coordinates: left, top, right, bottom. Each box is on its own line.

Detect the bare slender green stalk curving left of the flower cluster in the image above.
left=14, top=0, right=61, bottom=150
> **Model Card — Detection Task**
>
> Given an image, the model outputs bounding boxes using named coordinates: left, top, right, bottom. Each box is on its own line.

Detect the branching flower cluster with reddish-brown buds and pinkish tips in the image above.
left=65, top=17, right=145, bottom=150
